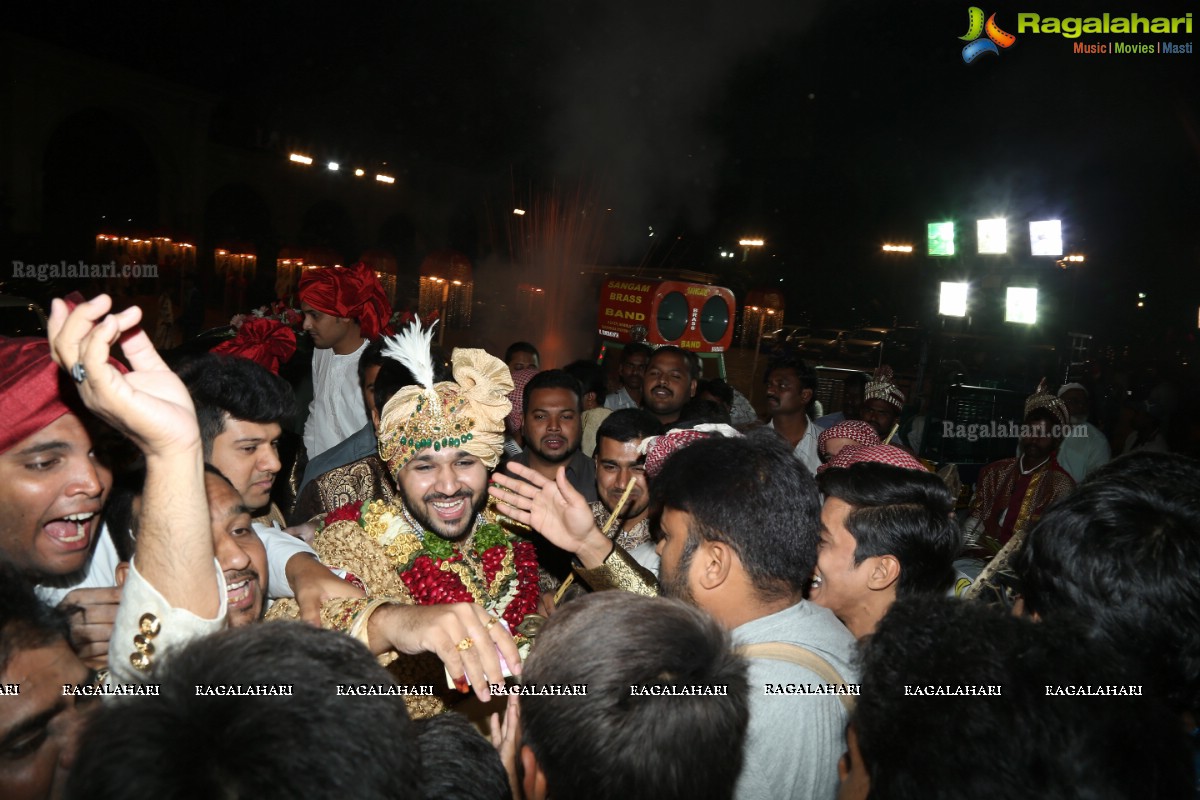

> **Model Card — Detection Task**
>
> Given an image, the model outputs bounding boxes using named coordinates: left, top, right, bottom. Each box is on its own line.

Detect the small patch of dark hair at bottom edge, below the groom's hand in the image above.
left=413, top=714, right=512, bottom=800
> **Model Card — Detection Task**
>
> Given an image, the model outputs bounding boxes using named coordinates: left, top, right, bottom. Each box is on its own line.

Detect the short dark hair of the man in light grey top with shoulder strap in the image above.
left=650, top=428, right=821, bottom=601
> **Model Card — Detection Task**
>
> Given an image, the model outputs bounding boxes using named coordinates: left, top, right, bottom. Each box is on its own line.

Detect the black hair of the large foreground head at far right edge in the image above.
left=1014, top=470, right=1200, bottom=710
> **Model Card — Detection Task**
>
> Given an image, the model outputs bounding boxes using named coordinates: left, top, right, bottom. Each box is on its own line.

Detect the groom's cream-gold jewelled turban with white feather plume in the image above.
left=379, top=318, right=512, bottom=475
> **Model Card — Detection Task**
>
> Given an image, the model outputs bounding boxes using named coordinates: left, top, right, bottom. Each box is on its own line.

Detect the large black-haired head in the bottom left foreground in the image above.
left=67, top=622, right=421, bottom=800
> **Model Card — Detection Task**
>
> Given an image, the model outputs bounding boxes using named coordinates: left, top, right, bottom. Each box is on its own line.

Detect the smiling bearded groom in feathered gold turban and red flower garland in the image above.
left=268, top=323, right=540, bottom=717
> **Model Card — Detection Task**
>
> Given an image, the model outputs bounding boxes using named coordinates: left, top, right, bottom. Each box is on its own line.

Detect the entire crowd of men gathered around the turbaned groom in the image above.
left=0, top=266, right=1200, bottom=800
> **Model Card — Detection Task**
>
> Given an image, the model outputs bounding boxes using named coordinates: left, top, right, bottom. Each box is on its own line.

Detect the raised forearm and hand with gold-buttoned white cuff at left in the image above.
left=49, top=295, right=226, bottom=681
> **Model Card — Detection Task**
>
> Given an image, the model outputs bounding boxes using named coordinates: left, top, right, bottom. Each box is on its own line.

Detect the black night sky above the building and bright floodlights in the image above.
left=7, top=0, right=1200, bottom=335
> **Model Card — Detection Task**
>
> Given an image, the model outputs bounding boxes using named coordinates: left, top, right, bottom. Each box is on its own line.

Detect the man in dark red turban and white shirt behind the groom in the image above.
left=300, top=263, right=391, bottom=458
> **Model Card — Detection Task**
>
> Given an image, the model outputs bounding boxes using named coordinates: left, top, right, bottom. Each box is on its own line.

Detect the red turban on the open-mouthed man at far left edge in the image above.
left=0, top=336, right=125, bottom=452
